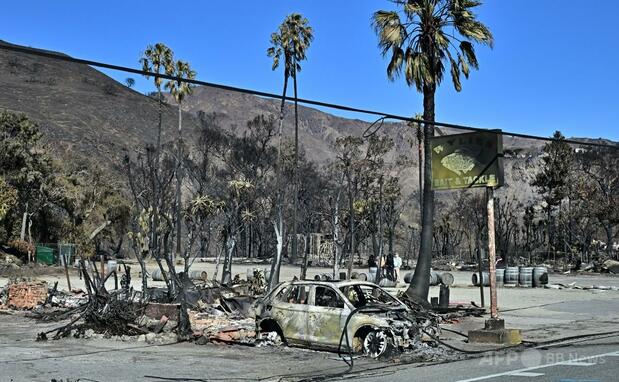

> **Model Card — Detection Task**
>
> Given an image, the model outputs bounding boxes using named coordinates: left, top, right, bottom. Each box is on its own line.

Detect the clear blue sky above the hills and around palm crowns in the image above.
left=0, top=0, right=619, bottom=140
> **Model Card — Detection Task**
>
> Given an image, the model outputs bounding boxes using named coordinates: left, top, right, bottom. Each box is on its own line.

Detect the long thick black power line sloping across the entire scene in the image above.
left=0, top=43, right=619, bottom=149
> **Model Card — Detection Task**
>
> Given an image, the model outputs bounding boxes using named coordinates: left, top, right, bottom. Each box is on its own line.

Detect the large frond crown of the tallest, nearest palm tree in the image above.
left=372, top=0, right=494, bottom=91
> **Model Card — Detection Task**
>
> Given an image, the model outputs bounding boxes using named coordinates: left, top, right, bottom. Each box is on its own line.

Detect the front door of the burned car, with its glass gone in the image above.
left=307, top=285, right=350, bottom=348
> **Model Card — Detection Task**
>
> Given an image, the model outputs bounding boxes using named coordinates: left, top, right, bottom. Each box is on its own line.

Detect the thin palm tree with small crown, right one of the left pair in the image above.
left=165, top=60, right=196, bottom=257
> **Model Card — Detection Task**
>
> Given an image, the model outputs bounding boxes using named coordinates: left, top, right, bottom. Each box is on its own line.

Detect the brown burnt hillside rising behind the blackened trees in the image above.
left=0, top=42, right=592, bottom=213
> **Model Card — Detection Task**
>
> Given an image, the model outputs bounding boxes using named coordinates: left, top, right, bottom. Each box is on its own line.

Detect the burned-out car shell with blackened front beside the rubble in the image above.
left=255, top=281, right=434, bottom=358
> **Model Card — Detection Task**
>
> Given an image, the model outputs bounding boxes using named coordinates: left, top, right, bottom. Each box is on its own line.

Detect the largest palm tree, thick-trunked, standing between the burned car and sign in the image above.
left=372, top=0, right=493, bottom=300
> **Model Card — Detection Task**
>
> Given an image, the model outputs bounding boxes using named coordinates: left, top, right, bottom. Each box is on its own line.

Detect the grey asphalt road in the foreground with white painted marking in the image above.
left=0, top=310, right=619, bottom=382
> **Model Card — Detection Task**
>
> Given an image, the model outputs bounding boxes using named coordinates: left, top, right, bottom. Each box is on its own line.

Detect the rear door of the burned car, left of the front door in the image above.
left=273, top=284, right=309, bottom=346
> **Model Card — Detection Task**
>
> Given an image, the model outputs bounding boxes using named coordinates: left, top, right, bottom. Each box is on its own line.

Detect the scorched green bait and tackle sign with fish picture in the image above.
left=432, top=130, right=504, bottom=190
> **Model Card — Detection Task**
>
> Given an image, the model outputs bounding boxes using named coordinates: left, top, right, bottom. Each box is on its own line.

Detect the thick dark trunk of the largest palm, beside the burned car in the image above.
left=406, top=85, right=436, bottom=301
